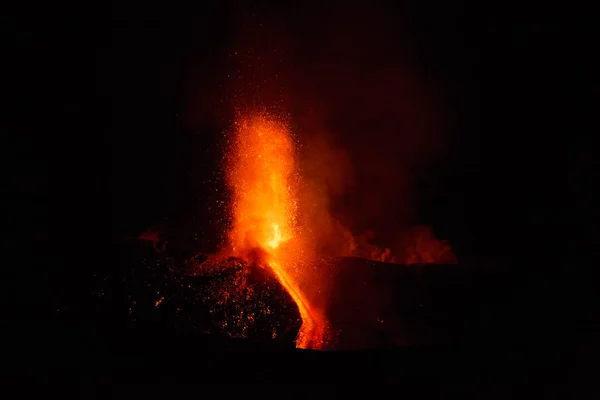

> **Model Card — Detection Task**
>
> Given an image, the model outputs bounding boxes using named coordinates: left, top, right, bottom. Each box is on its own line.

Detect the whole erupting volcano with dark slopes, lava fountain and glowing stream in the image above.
left=103, top=109, right=462, bottom=350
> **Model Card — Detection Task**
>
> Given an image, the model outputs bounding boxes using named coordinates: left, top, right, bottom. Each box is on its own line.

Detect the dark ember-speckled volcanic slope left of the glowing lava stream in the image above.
left=90, top=244, right=301, bottom=347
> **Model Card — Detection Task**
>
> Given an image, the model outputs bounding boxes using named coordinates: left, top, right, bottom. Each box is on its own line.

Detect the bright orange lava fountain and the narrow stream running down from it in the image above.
left=226, top=112, right=327, bottom=349
